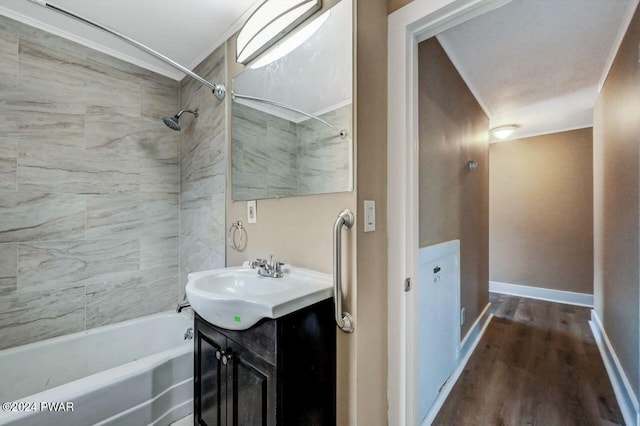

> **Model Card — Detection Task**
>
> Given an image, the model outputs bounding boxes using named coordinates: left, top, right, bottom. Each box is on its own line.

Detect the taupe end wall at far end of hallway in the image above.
left=489, top=128, right=593, bottom=294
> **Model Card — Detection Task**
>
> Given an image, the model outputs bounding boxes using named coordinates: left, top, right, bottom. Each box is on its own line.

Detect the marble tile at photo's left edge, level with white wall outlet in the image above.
left=0, top=191, right=85, bottom=243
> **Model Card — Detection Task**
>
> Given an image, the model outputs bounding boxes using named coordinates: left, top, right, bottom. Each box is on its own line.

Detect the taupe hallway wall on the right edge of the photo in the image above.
left=593, top=2, right=640, bottom=397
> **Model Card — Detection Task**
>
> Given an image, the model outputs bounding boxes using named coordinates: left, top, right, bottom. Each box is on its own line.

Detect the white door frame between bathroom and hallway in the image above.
left=387, top=0, right=511, bottom=426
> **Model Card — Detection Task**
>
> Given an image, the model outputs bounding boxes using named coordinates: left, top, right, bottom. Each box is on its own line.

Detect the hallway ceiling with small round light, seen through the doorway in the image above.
left=438, top=0, right=637, bottom=143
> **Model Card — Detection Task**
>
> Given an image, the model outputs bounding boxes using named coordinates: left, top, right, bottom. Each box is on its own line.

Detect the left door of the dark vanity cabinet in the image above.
left=194, top=321, right=227, bottom=426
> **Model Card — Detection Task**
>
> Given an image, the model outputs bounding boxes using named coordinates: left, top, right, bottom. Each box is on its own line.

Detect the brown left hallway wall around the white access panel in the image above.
left=418, top=38, right=489, bottom=336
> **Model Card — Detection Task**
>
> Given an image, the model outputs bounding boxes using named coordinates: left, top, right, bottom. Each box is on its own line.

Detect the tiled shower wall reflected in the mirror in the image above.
left=231, top=103, right=353, bottom=200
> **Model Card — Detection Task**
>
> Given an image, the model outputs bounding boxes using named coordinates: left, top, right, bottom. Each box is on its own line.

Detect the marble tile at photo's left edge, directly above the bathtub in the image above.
left=0, top=287, right=85, bottom=349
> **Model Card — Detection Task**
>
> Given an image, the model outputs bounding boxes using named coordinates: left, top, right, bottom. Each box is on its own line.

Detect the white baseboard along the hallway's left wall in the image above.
left=422, top=303, right=493, bottom=426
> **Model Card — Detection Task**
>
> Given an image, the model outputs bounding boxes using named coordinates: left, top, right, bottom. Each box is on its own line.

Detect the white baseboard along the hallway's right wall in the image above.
left=589, top=310, right=640, bottom=426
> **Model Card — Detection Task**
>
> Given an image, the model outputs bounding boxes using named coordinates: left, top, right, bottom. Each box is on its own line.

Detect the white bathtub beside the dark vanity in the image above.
left=0, top=313, right=193, bottom=426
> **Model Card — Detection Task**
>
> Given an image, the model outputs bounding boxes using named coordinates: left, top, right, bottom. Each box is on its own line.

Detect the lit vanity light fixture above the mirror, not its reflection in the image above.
left=236, top=0, right=322, bottom=65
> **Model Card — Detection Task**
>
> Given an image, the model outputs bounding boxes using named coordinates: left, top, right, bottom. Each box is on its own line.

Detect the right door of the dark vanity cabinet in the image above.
left=227, top=340, right=276, bottom=426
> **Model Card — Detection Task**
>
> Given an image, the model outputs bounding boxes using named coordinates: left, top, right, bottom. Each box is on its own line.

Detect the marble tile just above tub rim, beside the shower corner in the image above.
left=87, top=268, right=178, bottom=329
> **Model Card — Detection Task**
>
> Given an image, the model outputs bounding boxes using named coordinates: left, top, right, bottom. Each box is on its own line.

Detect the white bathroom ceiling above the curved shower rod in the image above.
left=0, top=0, right=263, bottom=80
